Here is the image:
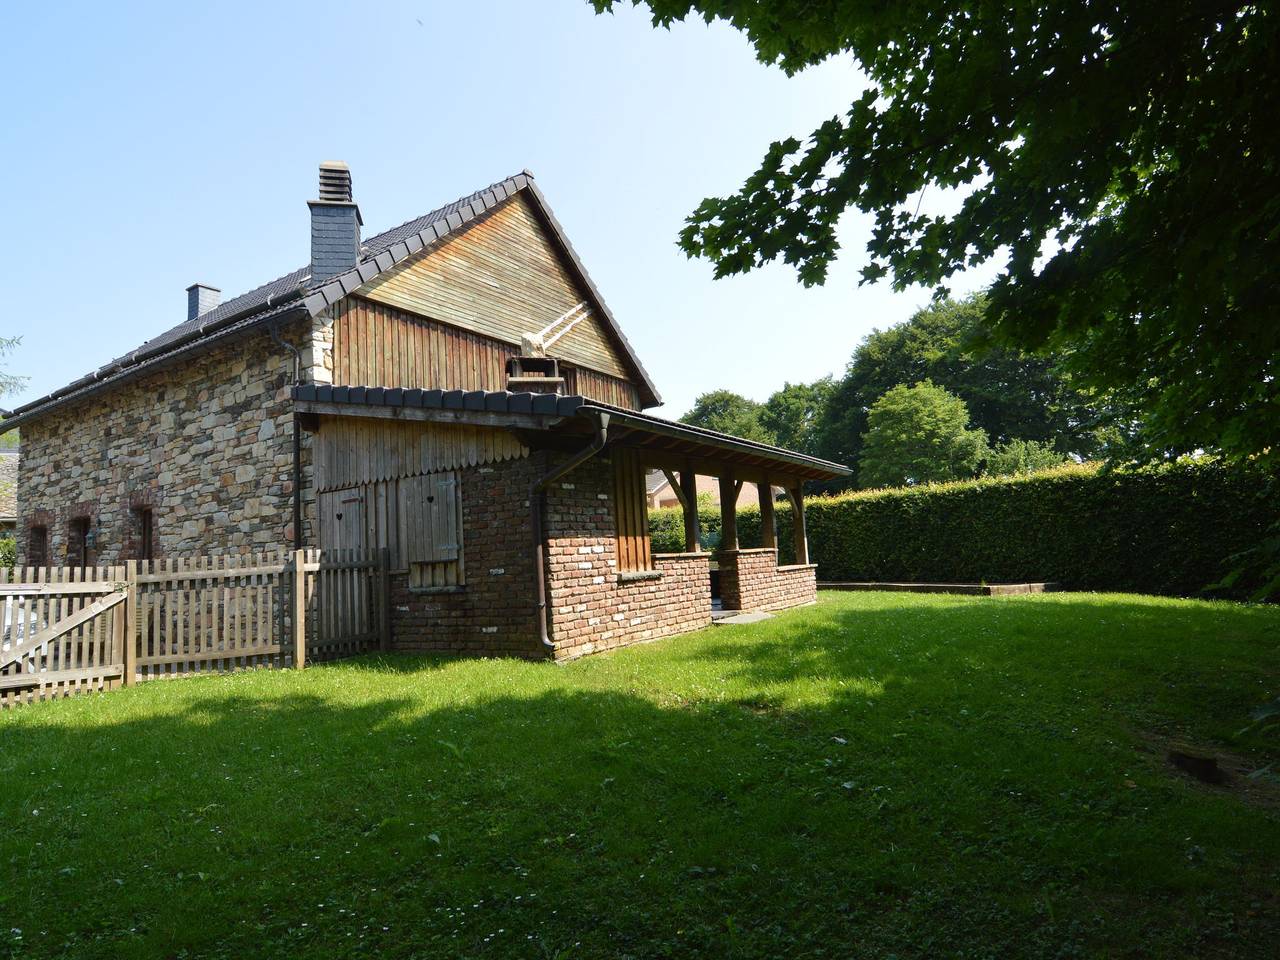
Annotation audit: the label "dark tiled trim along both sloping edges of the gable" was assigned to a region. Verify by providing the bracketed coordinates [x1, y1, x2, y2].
[303, 170, 662, 407]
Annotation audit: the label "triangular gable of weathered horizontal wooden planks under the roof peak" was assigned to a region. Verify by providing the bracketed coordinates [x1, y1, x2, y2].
[356, 193, 635, 389]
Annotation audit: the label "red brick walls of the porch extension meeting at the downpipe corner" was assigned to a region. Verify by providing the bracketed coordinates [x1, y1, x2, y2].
[392, 453, 712, 659]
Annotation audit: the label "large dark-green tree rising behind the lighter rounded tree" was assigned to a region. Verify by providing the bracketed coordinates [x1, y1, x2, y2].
[818, 294, 1134, 481]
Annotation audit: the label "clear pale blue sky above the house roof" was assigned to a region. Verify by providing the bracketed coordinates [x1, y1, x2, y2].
[0, 0, 992, 417]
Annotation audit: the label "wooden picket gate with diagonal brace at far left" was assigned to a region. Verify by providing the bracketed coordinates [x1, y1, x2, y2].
[0, 567, 128, 707]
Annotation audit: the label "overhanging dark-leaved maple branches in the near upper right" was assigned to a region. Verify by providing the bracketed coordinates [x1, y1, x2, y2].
[593, 0, 1280, 465]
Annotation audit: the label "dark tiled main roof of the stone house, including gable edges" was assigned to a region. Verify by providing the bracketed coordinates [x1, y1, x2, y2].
[0, 170, 662, 433]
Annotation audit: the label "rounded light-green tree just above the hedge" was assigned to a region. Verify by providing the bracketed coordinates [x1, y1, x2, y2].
[858, 380, 987, 486]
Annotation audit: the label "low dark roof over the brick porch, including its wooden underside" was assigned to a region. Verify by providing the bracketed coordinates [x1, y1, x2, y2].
[293, 384, 850, 483]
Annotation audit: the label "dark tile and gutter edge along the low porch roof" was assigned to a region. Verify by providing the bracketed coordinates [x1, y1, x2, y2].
[293, 384, 852, 479]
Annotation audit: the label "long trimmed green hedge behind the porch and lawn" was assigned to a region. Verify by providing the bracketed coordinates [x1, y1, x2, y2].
[650, 463, 1280, 596]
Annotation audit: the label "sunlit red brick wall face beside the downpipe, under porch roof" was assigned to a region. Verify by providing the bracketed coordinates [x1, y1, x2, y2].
[547, 457, 712, 659]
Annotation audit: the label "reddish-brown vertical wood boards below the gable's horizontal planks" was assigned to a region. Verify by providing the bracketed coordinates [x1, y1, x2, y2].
[333, 297, 640, 410]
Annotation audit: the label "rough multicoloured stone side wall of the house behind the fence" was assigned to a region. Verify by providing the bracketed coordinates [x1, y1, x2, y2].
[18, 321, 315, 564]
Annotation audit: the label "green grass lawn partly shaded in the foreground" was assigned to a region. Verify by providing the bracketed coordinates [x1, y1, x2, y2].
[0, 594, 1280, 957]
